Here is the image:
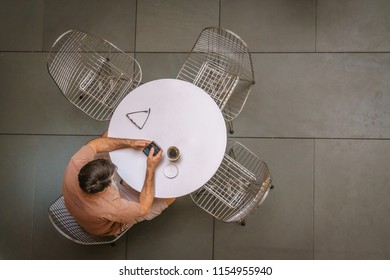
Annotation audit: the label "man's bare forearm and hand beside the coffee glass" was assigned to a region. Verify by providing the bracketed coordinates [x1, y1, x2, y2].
[139, 148, 162, 216]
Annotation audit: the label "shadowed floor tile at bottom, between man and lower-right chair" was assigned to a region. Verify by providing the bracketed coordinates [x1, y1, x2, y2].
[127, 196, 213, 260]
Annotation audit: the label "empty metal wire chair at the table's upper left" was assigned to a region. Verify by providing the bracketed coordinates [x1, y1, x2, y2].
[47, 29, 142, 121]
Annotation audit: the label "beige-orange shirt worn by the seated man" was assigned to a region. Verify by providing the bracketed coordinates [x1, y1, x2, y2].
[62, 144, 145, 235]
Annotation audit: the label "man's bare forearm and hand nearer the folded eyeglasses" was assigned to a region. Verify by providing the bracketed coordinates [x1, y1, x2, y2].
[88, 137, 150, 153]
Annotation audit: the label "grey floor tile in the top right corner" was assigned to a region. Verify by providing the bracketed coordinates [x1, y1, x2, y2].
[317, 0, 390, 52]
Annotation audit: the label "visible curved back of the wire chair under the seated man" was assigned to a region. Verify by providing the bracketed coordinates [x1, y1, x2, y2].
[49, 196, 126, 245]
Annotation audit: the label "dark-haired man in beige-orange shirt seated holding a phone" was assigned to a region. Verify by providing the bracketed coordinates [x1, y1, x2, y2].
[62, 134, 174, 236]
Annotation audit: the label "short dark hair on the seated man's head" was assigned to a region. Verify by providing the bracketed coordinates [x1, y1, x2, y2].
[79, 159, 116, 194]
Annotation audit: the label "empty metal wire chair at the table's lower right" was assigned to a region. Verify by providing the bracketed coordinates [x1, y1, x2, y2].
[191, 141, 273, 225]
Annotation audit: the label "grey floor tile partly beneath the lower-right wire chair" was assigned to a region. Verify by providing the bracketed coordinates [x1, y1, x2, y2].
[214, 138, 314, 259]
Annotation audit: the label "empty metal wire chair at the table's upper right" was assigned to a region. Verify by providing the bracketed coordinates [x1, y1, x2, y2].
[177, 27, 255, 133]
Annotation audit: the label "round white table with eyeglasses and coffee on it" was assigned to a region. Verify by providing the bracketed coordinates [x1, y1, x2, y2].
[108, 79, 227, 198]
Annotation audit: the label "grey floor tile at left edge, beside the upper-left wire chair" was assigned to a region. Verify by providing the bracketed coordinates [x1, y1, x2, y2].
[0, 53, 108, 135]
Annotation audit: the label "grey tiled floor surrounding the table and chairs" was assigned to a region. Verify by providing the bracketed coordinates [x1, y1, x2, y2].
[0, 0, 390, 259]
